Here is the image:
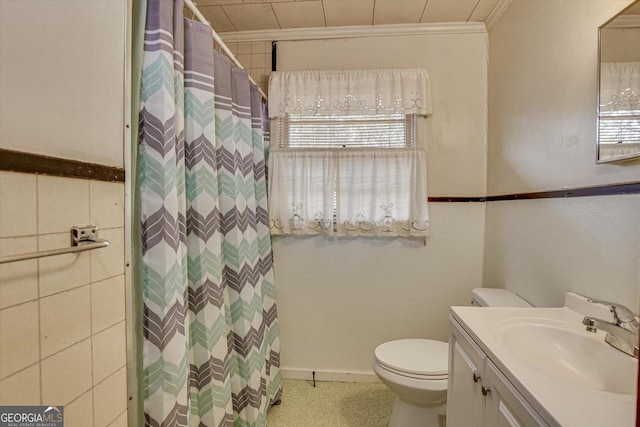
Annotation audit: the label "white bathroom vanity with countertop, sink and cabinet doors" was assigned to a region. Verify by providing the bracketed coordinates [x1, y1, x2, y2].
[447, 293, 638, 427]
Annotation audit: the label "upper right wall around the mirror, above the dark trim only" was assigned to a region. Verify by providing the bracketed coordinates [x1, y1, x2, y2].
[487, 0, 640, 195]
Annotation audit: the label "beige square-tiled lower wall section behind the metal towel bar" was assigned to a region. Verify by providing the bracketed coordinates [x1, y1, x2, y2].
[0, 172, 127, 427]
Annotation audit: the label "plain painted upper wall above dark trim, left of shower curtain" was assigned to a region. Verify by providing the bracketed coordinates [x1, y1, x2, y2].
[0, 0, 126, 167]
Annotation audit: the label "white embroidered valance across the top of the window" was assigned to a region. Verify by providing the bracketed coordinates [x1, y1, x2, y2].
[269, 69, 431, 118]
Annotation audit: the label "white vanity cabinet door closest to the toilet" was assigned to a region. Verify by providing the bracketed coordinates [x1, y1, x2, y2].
[447, 318, 485, 427]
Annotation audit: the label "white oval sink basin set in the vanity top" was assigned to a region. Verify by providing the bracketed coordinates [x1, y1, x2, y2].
[495, 318, 637, 395]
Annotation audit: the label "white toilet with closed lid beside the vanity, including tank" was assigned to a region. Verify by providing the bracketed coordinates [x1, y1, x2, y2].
[373, 288, 531, 427]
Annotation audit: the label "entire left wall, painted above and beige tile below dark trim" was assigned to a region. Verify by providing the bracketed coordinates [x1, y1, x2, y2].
[0, 1, 127, 427]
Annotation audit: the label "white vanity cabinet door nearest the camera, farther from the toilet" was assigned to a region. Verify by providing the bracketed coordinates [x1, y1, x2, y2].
[484, 360, 547, 427]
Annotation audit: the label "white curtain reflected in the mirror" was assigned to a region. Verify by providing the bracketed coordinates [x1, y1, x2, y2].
[600, 62, 640, 116]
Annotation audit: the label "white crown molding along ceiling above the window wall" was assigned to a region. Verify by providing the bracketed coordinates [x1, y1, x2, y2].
[219, 22, 487, 43]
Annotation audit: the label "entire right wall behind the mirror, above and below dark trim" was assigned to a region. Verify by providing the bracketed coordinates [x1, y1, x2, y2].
[483, 0, 640, 311]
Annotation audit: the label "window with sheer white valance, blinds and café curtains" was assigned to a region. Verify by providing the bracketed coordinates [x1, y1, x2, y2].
[269, 70, 430, 237]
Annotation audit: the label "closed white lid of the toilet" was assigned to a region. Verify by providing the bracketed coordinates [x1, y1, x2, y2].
[375, 339, 449, 377]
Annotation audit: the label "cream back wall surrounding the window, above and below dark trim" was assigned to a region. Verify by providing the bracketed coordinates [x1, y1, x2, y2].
[273, 32, 487, 378]
